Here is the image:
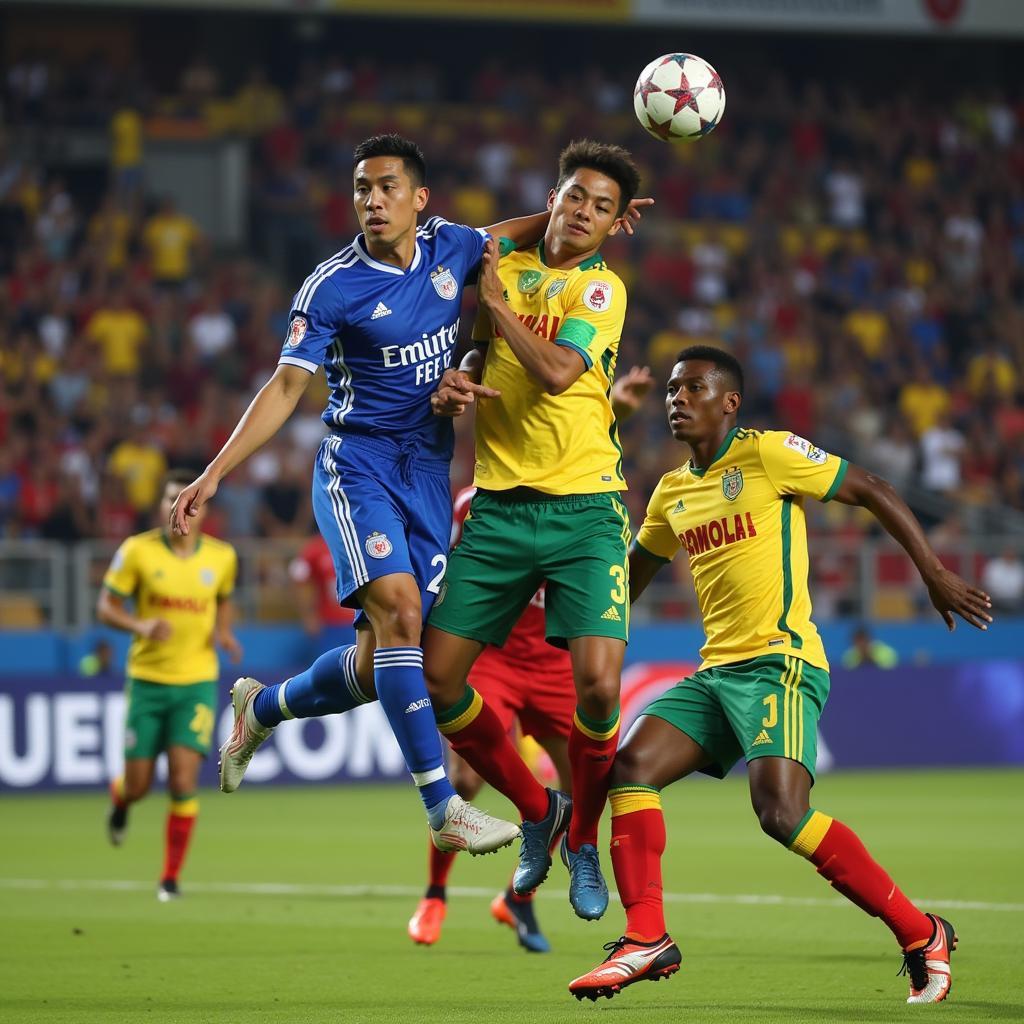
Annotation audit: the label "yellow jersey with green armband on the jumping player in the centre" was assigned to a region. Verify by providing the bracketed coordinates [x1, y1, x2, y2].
[473, 239, 626, 495]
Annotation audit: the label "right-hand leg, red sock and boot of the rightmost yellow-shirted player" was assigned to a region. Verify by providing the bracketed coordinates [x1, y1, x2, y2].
[750, 757, 956, 1002]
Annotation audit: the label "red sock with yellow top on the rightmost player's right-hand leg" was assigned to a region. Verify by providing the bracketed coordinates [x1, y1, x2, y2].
[787, 809, 932, 949]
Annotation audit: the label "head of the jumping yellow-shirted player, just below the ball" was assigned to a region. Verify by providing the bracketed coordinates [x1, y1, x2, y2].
[548, 138, 640, 252]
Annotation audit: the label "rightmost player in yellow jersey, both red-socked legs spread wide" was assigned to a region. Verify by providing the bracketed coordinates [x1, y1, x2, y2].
[569, 346, 992, 1002]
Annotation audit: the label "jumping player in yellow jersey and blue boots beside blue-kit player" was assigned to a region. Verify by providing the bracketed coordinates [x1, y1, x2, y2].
[424, 141, 639, 920]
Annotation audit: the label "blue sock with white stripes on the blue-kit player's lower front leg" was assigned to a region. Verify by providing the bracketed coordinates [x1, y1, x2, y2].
[374, 647, 456, 828]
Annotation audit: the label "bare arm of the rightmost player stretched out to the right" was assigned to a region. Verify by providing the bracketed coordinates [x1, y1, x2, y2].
[834, 464, 992, 631]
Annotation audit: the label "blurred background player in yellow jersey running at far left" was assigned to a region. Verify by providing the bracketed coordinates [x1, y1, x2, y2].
[96, 470, 242, 901]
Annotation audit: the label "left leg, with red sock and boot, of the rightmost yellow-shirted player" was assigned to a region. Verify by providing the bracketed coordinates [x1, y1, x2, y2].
[569, 716, 692, 999]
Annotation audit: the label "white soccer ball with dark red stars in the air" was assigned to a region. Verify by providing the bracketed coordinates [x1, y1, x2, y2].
[633, 53, 725, 142]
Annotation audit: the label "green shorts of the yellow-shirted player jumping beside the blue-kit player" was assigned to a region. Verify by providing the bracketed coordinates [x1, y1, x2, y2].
[429, 487, 630, 647]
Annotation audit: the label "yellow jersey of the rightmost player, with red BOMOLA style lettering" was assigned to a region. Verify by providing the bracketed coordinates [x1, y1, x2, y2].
[636, 427, 847, 671]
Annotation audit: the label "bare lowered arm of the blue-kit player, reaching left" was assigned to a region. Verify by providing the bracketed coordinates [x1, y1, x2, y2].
[170, 364, 312, 534]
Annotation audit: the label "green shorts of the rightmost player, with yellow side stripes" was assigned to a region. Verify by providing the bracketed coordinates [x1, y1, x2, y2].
[643, 654, 828, 781]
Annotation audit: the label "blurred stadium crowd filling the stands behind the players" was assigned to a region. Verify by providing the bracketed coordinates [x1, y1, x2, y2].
[0, 41, 1024, 606]
